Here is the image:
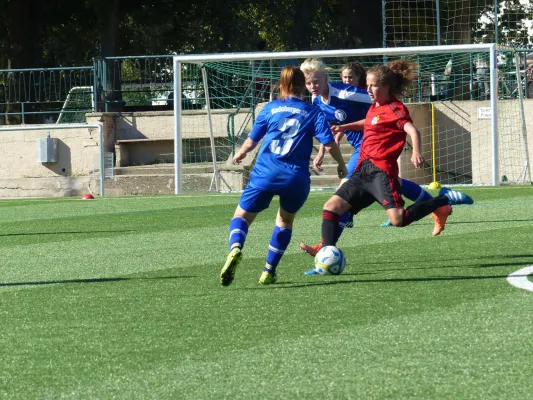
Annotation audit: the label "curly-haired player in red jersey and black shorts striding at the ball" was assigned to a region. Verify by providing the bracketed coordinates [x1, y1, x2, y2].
[322, 60, 473, 250]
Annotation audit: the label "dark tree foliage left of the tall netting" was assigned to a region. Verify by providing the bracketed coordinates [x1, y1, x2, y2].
[0, 0, 381, 68]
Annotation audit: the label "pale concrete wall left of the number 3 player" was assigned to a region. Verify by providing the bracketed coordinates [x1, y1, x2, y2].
[0, 109, 251, 197]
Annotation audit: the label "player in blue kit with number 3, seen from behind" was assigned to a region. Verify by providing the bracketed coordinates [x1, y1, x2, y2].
[220, 66, 347, 286]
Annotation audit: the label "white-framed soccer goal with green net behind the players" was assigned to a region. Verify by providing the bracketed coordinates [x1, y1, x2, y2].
[174, 44, 531, 193]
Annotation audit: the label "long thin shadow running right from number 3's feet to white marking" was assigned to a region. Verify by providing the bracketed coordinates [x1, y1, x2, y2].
[242, 274, 508, 290]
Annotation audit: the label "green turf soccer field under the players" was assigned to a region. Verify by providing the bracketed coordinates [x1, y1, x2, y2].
[0, 186, 533, 400]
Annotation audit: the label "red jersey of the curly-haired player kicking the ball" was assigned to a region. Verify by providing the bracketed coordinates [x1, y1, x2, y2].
[357, 97, 412, 177]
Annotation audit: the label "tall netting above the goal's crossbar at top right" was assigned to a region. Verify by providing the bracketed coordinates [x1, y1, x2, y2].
[382, 0, 533, 47]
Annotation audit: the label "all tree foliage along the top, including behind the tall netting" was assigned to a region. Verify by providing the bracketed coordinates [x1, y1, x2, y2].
[0, 0, 533, 68]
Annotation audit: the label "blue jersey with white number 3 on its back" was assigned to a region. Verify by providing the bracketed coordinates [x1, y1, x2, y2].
[249, 97, 334, 190]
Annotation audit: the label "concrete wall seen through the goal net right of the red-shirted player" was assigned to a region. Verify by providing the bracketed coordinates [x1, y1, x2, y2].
[399, 99, 533, 185]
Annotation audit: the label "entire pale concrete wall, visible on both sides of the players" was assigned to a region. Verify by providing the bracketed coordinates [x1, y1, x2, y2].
[0, 100, 533, 197]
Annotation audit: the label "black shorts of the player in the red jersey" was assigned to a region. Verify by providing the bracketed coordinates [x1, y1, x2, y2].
[335, 160, 404, 214]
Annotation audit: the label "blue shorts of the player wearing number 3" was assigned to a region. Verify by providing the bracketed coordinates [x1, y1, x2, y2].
[239, 182, 311, 214]
